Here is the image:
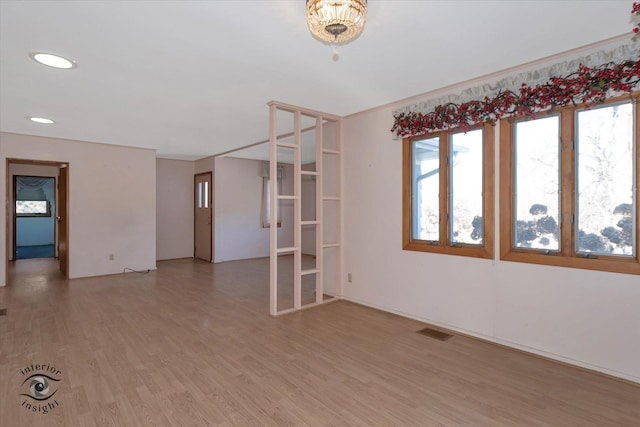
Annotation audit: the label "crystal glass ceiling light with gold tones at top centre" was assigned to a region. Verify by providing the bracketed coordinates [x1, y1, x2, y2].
[307, 0, 367, 45]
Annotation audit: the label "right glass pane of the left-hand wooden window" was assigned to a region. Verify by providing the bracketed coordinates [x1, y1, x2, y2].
[449, 129, 484, 245]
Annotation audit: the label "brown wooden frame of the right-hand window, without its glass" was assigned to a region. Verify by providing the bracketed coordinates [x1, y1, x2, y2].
[500, 92, 640, 274]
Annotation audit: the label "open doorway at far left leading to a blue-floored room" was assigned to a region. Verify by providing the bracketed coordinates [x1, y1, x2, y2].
[5, 159, 69, 283]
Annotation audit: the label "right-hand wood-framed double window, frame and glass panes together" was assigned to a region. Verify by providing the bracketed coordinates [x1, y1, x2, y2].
[500, 94, 640, 274]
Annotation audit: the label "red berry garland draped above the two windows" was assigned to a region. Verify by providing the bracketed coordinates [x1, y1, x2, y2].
[391, 59, 640, 137]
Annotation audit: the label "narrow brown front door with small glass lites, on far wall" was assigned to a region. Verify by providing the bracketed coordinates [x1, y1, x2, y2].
[193, 172, 213, 262]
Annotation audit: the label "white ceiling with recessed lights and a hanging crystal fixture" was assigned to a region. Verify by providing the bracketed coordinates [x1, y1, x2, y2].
[0, 0, 632, 159]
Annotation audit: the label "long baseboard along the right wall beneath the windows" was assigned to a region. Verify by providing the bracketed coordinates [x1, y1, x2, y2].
[342, 296, 640, 387]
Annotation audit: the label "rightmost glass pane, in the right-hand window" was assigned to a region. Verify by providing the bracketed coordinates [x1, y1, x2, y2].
[576, 103, 637, 255]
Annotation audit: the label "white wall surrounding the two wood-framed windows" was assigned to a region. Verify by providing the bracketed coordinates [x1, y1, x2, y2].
[344, 45, 640, 382]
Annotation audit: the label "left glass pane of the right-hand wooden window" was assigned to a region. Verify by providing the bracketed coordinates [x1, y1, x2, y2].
[513, 116, 560, 251]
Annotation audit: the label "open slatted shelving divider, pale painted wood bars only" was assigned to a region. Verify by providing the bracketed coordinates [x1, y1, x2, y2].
[268, 101, 343, 316]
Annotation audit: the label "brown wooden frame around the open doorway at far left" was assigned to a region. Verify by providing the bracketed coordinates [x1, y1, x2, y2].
[4, 157, 70, 285]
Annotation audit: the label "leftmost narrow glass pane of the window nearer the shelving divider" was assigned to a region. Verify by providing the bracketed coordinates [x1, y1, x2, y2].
[411, 138, 440, 241]
